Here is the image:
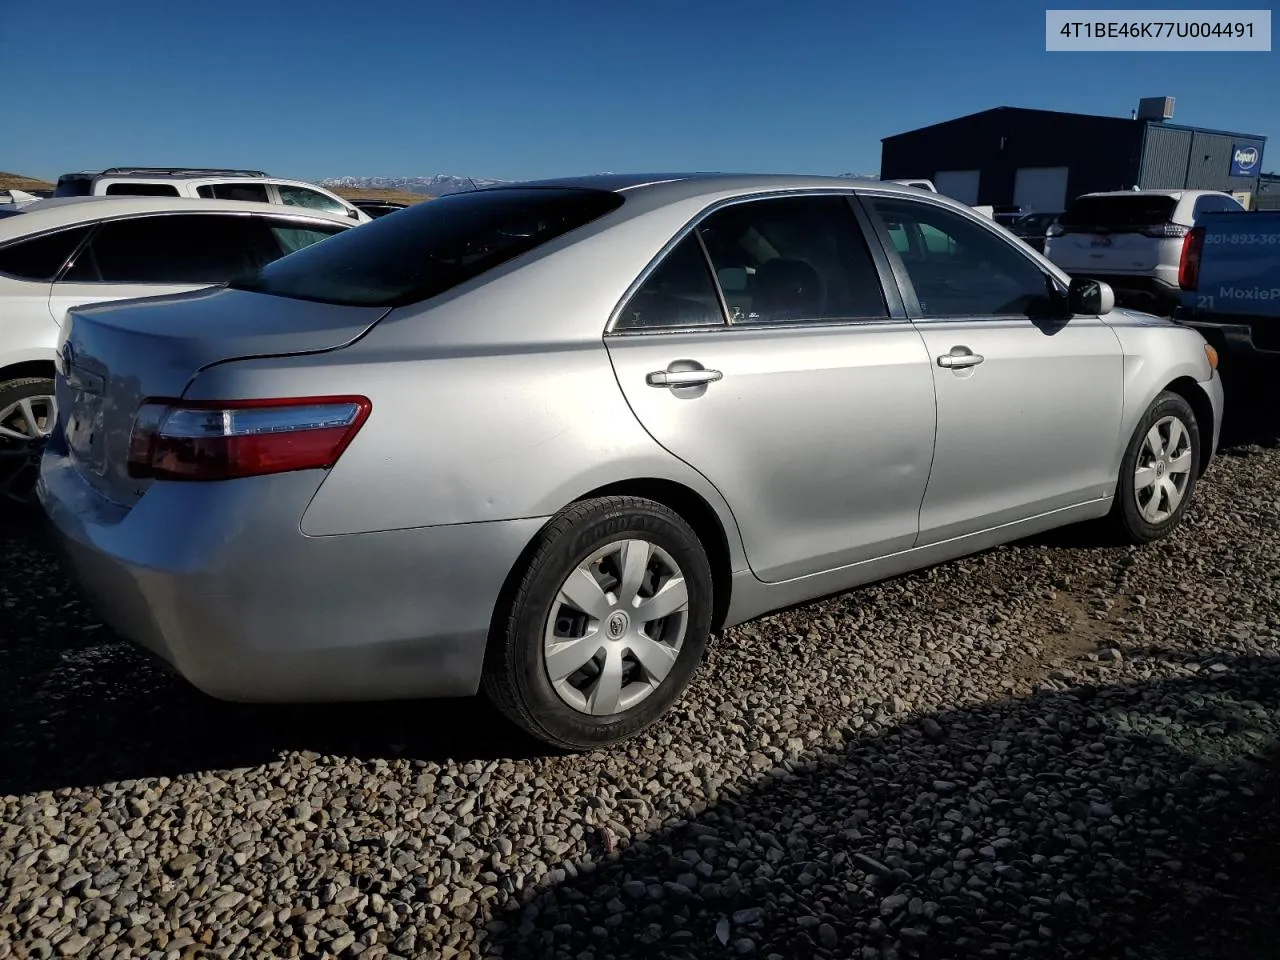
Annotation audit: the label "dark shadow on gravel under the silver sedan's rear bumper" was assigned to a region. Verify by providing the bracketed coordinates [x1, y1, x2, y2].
[0, 508, 538, 795]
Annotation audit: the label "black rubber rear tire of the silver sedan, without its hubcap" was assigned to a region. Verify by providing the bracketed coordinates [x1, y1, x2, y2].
[484, 497, 712, 750]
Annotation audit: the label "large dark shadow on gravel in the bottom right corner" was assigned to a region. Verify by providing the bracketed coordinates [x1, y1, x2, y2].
[477, 658, 1280, 960]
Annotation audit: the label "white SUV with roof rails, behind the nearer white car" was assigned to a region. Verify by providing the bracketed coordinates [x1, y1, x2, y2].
[54, 166, 372, 223]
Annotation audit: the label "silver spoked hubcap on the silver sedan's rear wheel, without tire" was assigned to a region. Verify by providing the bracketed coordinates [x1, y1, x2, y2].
[543, 540, 689, 717]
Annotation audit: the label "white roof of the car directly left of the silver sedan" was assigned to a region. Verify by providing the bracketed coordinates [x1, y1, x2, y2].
[0, 197, 356, 239]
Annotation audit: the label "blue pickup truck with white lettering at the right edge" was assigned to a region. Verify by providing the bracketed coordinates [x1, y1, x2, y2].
[1174, 211, 1280, 357]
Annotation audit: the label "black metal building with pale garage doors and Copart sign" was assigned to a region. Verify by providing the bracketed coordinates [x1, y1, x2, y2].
[881, 97, 1266, 212]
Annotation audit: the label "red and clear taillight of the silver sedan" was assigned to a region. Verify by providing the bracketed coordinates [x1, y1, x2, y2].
[129, 397, 372, 480]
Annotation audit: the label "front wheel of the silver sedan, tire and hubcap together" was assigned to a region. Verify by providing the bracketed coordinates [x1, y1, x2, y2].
[1111, 392, 1201, 544]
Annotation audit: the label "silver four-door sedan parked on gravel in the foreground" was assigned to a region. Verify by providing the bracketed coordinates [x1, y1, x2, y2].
[40, 175, 1222, 749]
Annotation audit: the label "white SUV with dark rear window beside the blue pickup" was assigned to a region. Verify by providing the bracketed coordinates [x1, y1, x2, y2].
[1044, 189, 1244, 315]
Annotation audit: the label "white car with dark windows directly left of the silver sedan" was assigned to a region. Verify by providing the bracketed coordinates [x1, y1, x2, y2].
[0, 197, 356, 502]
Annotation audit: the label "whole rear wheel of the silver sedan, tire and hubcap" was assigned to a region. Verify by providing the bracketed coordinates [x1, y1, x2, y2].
[484, 497, 712, 750]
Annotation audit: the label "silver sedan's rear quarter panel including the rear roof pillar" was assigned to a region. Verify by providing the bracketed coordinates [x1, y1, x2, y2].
[186, 202, 746, 570]
